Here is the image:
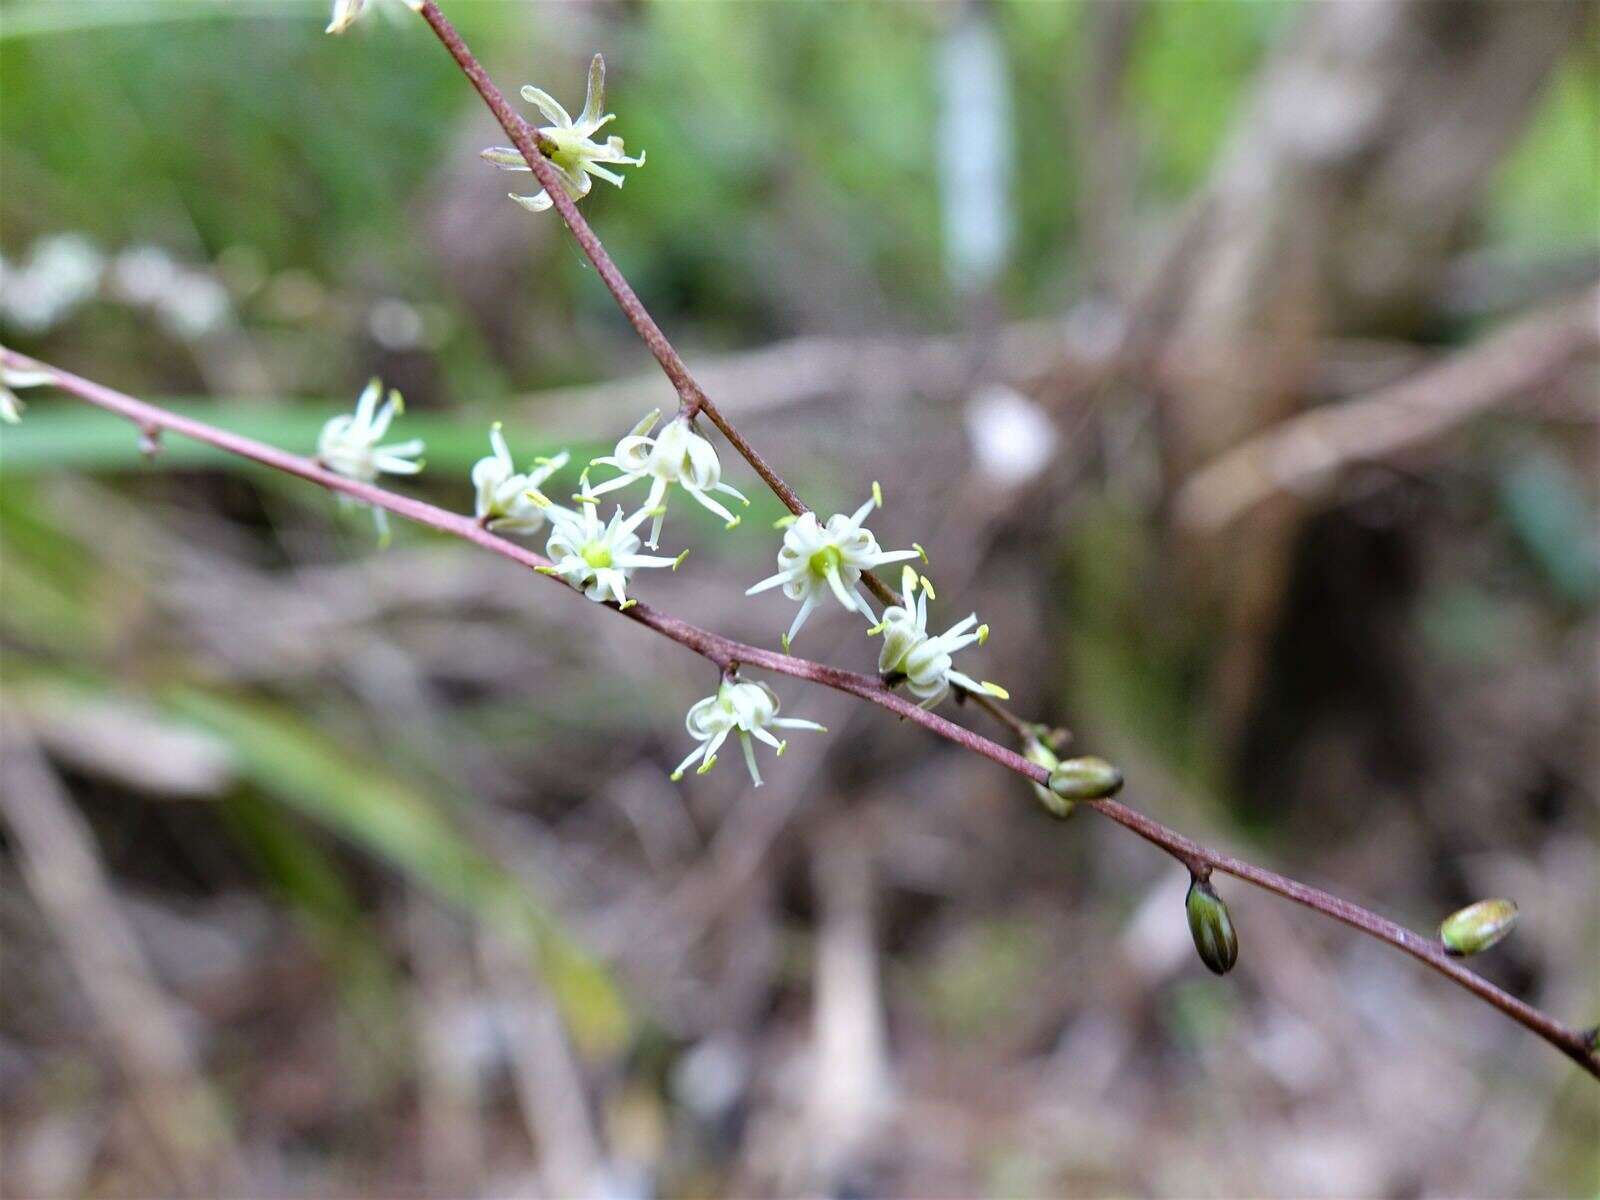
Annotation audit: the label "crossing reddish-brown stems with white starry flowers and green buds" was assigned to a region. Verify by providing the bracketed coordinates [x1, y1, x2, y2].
[0, 0, 1600, 1078]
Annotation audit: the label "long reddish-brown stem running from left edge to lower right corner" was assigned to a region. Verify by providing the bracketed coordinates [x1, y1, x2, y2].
[15, 347, 1600, 1080]
